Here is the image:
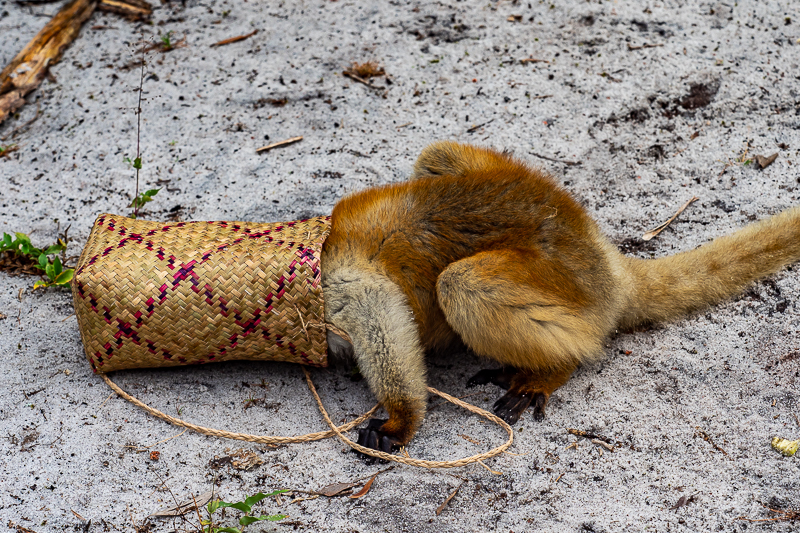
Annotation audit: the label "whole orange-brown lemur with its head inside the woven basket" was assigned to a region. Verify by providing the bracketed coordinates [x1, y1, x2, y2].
[321, 142, 800, 451]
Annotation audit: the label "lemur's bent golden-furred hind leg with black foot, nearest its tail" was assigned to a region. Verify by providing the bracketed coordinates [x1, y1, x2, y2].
[436, 250, 604, 424]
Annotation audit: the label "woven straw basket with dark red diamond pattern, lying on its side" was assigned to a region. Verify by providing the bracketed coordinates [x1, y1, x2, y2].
[72, 214, 330, 373]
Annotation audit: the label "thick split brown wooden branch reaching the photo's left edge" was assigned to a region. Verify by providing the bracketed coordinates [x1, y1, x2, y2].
[0, 0, 98, 123]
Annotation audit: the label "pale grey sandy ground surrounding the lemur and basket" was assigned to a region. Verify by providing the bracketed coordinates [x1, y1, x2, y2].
[0, 0, 800, 533]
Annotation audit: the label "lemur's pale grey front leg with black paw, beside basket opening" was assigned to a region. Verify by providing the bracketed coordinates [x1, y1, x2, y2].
[322, 265, 428, 450]
